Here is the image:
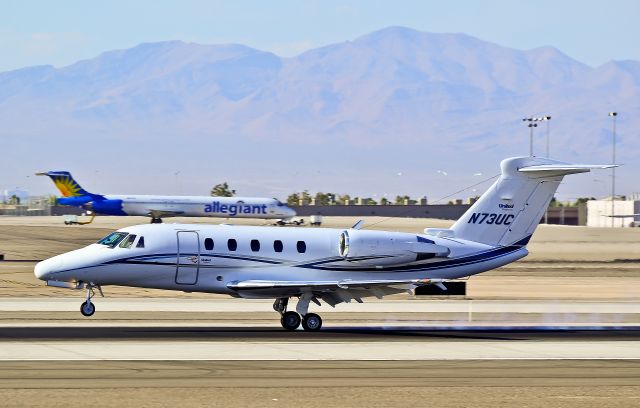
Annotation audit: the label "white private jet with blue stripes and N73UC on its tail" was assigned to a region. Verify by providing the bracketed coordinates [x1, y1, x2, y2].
[35, 157, 611, 331]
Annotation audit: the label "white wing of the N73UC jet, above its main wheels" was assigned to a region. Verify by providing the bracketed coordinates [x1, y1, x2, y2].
[227, 279, 446, 306]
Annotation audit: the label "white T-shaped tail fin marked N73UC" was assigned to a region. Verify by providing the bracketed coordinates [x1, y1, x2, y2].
[451, 157, 614, 245]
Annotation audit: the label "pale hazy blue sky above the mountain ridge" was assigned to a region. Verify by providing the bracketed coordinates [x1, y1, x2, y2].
[0, 0, 640, 71]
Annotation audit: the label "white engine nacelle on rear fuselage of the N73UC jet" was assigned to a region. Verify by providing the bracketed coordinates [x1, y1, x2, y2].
[338, 229, 451, 266]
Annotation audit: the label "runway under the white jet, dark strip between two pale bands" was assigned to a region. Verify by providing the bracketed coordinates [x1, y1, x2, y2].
[0, 298, 640, 361]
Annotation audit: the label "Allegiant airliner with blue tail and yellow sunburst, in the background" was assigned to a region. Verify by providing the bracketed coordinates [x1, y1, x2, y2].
[36, 171, 296, 224]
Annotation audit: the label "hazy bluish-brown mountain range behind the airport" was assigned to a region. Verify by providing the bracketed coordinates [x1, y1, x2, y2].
[0, 27, 640, 198]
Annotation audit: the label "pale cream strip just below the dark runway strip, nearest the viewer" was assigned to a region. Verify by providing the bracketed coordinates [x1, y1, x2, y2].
[0, 341, 640, 361]
